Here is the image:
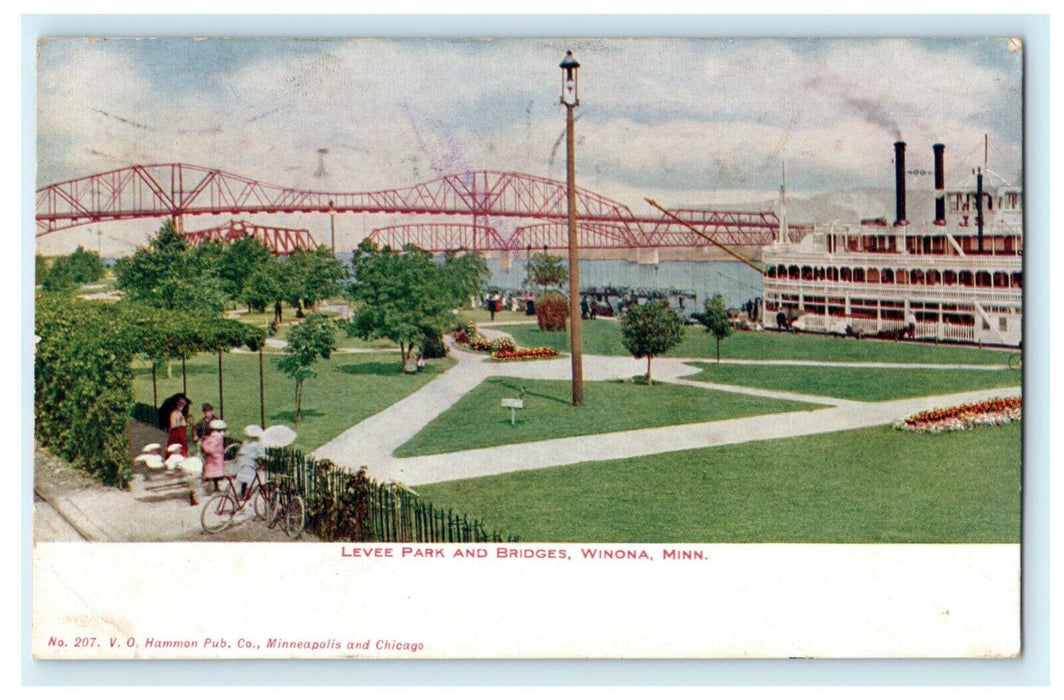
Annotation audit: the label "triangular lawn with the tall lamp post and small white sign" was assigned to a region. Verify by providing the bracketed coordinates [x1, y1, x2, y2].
[395, 377, 821, 456]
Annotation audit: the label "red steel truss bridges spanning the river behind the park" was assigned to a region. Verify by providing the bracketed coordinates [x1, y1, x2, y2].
[36, 163, 795, 252]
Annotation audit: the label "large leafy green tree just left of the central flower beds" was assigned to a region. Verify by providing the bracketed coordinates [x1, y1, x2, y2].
[348, 245, 480, 371]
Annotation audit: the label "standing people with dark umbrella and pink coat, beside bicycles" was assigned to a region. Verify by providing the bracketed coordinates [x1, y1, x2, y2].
[159, 394, 266, 505]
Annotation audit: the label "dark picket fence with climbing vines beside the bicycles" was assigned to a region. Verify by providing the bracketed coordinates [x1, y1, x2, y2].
[266, 449, 517, 543]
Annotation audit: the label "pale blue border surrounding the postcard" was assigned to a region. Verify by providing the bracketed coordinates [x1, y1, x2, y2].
[18, 9, 1050, 685]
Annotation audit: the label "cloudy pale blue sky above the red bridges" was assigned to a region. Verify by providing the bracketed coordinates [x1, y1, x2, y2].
[37, 38, 1023, 253]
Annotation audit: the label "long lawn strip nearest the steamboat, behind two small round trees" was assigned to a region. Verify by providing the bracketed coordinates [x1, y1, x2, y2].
[503, 320, 1009, 365]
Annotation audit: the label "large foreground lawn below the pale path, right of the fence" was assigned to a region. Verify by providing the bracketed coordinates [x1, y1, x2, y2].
[418, 423, 1021, 544]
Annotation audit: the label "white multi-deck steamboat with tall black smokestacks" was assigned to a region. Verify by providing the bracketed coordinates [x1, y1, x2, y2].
[763, 141, 1024, 346]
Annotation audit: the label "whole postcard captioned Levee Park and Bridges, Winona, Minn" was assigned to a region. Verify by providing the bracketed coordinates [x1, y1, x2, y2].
[32, 30, 1025, 660]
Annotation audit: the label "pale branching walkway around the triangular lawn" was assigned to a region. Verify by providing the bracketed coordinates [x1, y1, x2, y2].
[313, 327, 1020, 486]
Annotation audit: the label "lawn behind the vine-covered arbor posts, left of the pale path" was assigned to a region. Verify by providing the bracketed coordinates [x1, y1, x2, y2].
[133, 353, 454, 451]
